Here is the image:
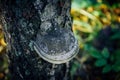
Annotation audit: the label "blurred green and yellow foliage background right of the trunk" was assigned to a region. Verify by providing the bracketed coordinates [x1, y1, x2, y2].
[71, 0, 120, 80]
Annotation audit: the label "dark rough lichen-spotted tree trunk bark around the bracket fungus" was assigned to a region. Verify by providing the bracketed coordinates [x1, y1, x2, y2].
[0, 0, 72, 80]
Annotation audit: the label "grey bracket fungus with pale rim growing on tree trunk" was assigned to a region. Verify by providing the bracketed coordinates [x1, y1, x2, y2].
[34, 27, 79, 64]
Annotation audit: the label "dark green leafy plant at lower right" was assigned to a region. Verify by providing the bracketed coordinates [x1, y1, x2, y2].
[89, 46, 120, 73]
